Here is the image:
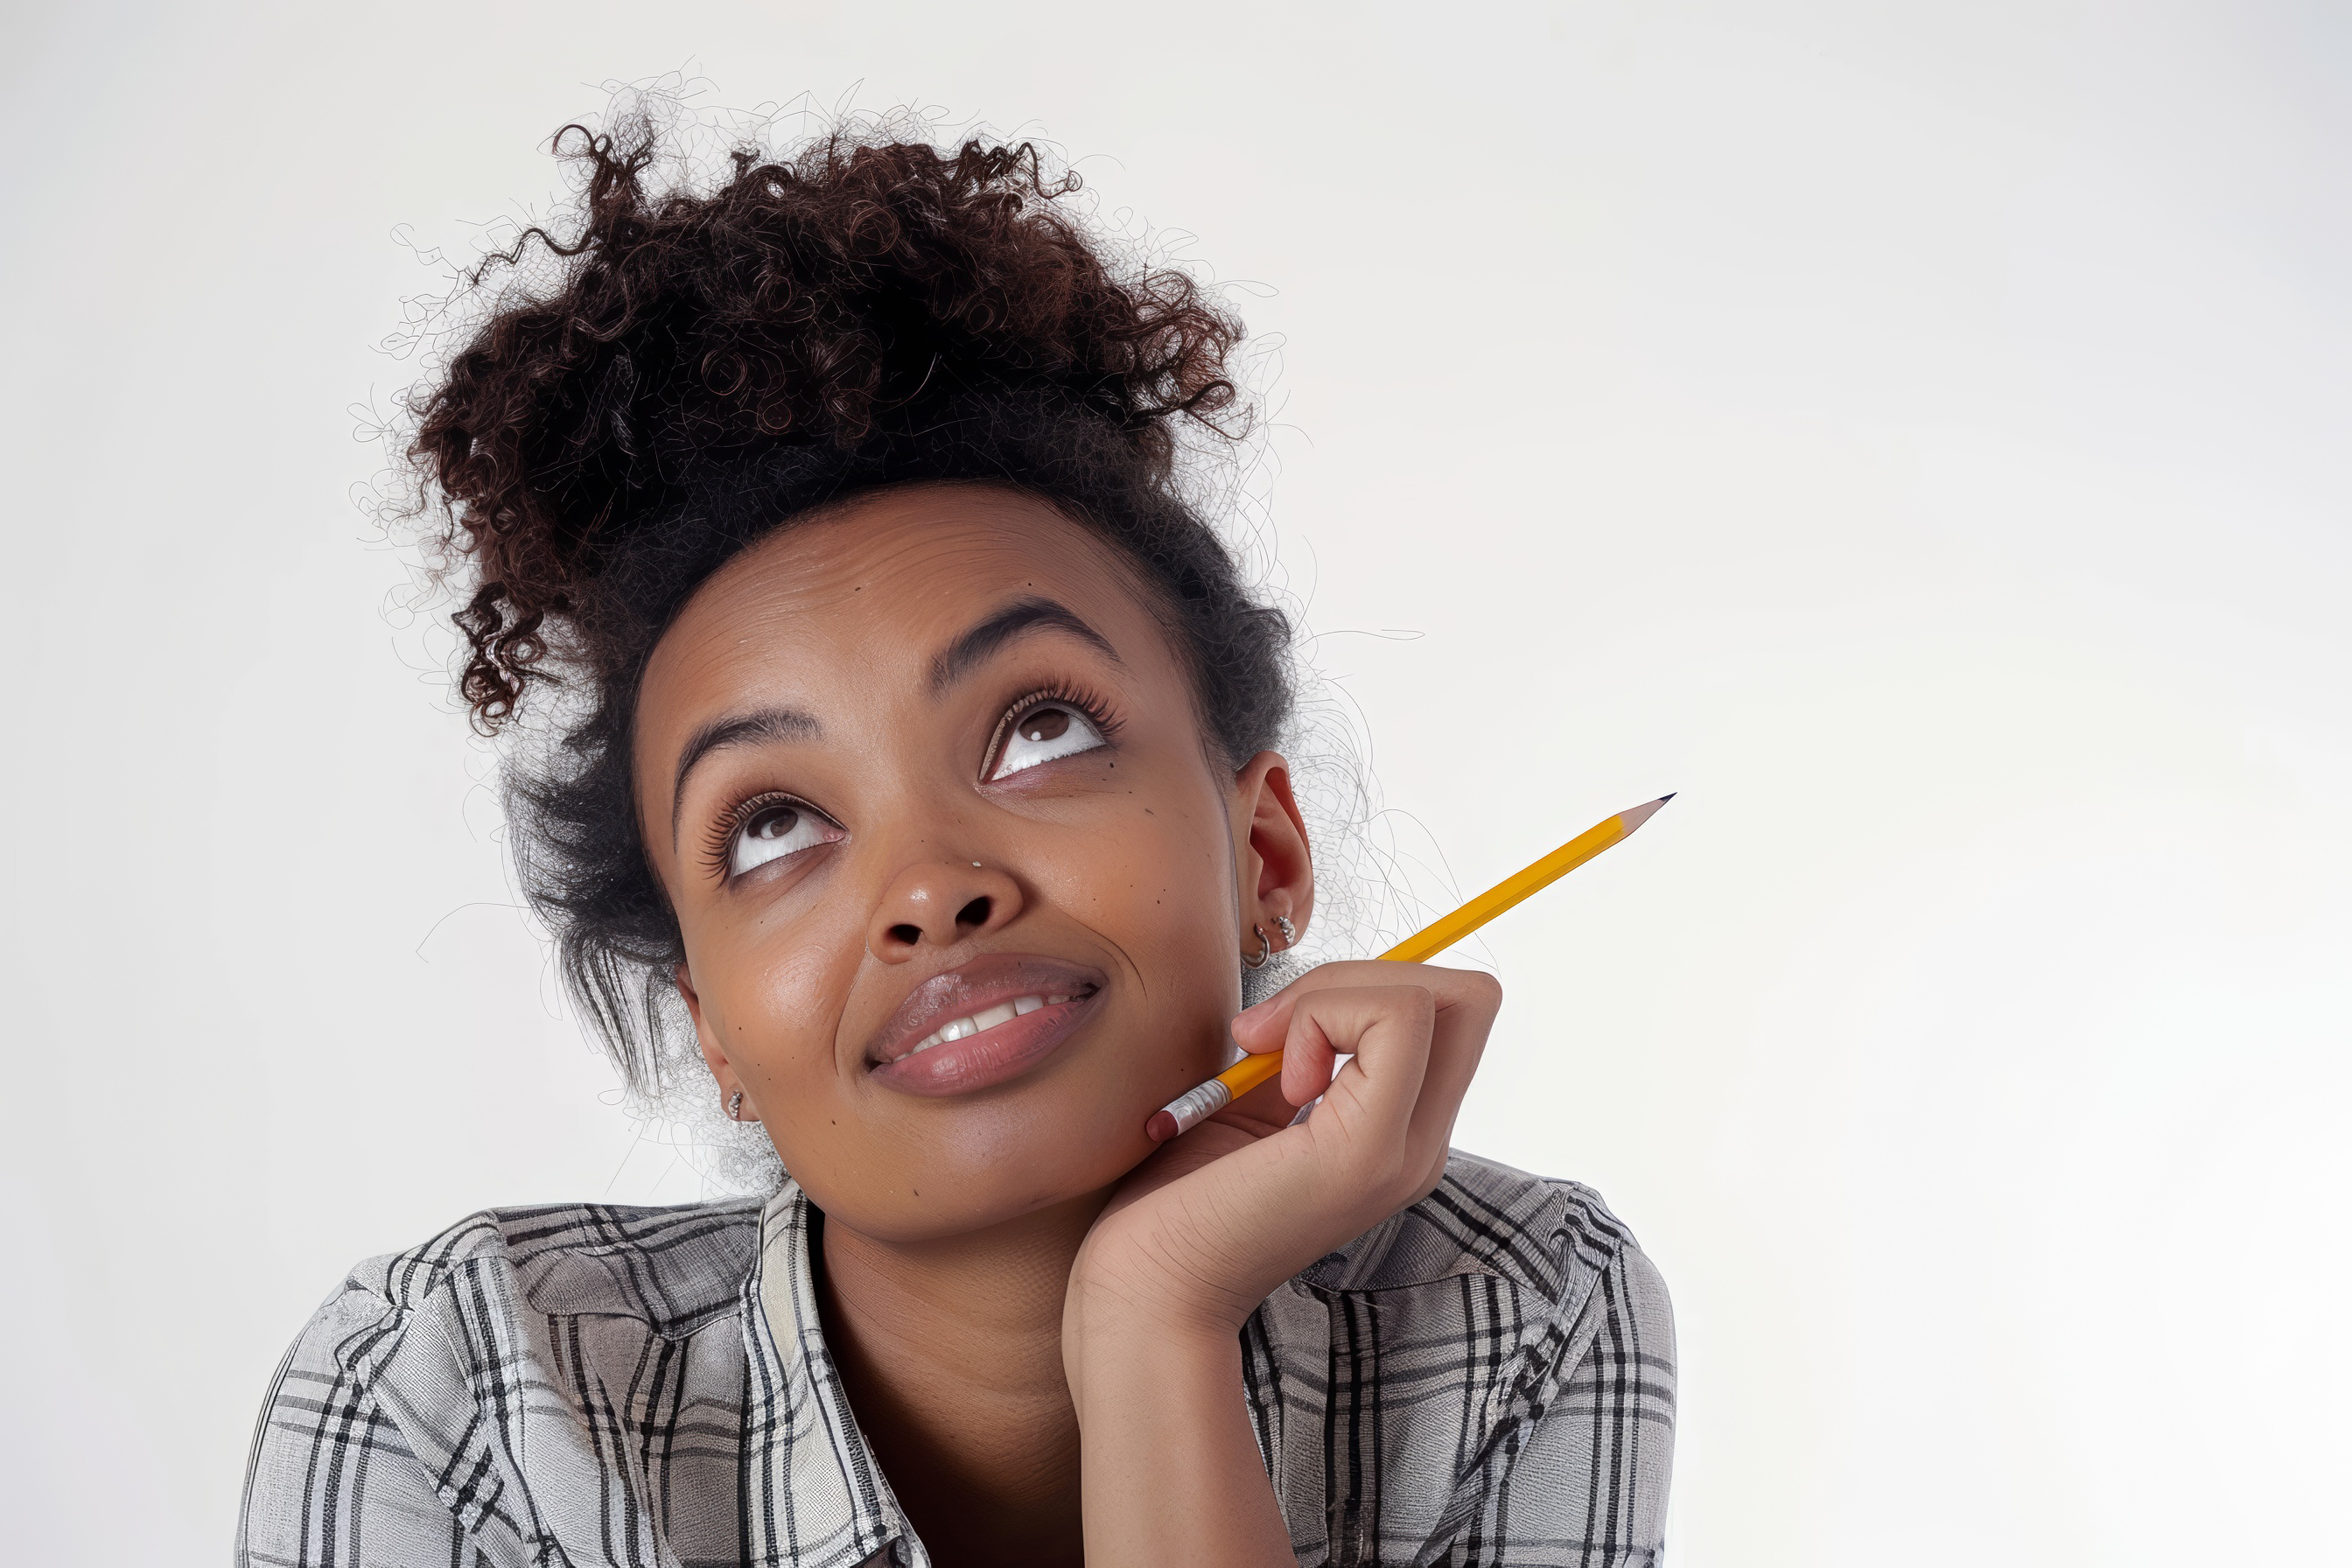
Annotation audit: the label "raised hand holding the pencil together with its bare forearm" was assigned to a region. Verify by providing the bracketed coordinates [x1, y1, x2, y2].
[1060, 962, 1503, 1568]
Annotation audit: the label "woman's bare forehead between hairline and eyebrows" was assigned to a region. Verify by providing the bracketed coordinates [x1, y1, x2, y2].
[637, 484, 1169, 738]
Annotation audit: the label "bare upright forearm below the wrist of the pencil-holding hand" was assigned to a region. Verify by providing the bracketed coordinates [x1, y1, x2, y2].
[1073, 1331, 1298, 1568]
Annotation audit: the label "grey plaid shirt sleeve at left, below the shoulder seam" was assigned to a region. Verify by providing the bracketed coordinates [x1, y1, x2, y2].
[235, 1286, 485, 1568]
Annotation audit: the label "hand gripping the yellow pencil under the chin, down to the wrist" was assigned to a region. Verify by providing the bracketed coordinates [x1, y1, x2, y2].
[1063, 962, 1503, 1354]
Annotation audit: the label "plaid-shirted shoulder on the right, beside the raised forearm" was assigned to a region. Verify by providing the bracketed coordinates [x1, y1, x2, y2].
[1242, 1152, 1675, 1564]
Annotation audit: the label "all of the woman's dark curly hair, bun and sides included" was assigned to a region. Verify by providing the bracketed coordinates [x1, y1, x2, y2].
[410, 120, 1293, 1096]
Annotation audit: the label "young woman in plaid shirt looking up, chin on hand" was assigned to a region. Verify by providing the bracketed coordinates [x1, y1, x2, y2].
[240, 120, 1672, 1568]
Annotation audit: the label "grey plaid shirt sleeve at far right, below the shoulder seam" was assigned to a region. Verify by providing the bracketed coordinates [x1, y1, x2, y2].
[1439, 1243, 1675, 1568]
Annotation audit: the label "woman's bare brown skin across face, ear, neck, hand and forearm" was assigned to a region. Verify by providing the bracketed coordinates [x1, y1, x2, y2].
[633, 484, 1501, 1568]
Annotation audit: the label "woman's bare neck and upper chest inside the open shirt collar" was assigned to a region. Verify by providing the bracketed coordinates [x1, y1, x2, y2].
[816, 1192, 1108, 1568]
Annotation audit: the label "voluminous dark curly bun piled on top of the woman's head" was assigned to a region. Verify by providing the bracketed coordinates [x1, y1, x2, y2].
[410, 116, 1242, 724]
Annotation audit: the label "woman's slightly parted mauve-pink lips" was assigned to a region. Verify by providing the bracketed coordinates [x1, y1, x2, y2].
[865, 955, 1105, 1098]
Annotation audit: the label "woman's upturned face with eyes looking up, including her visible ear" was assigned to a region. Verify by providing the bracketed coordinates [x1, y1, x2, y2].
[633, 484, 1310, 1242]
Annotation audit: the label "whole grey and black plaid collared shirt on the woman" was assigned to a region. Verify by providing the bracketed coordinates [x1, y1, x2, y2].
[237, 1154, 1675, 1568]
